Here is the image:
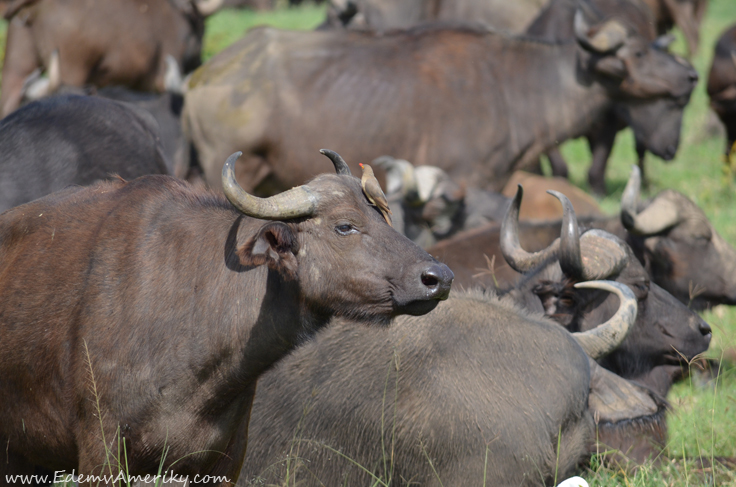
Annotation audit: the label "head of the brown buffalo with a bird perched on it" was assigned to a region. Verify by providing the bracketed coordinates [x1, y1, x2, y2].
[223, 150, 454, 323]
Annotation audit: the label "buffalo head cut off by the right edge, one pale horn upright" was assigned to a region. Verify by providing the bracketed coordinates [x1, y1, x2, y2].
[621, 167, 736, 309]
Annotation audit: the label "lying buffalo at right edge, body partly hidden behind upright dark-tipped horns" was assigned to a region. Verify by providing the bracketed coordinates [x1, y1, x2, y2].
[427, 168, 736, 309]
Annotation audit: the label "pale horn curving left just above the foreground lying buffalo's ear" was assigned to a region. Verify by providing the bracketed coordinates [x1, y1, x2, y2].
[572, 281, 638, 360]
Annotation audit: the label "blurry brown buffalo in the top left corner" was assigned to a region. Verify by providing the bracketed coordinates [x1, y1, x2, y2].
[0, 0, 222, 116]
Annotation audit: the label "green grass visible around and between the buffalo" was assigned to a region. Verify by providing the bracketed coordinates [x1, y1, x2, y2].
[0, 0, 736, 487]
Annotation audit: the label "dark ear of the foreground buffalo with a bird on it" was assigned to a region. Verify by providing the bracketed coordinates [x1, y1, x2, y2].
[235, 222, 299, 279]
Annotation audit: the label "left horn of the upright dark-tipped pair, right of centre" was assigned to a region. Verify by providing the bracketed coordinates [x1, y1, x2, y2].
[500, 184, 565, 273]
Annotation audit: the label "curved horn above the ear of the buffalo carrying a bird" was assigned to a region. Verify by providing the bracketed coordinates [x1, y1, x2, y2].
[222, 152, 318, 220]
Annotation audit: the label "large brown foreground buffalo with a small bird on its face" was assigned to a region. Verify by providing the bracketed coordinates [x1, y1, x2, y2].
[0, 152, 452, 485]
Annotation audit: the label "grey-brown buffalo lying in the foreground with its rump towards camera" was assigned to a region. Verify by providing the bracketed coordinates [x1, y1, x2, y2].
[239, 280, 662, 486]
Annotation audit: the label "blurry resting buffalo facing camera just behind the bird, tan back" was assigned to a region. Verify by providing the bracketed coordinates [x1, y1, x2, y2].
[373, 156, 603, 247]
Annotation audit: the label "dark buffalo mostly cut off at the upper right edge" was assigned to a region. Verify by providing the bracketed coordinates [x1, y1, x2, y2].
[708, 25, 736, 163]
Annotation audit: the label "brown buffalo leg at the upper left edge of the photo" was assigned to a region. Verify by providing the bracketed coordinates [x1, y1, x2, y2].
[0, 17, 40, 117]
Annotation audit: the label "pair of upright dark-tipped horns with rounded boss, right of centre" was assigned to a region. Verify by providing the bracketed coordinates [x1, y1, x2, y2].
[500, 185, 628, 281]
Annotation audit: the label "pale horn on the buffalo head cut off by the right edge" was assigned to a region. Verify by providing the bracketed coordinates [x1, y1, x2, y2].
[621, 166, 680, 236]
